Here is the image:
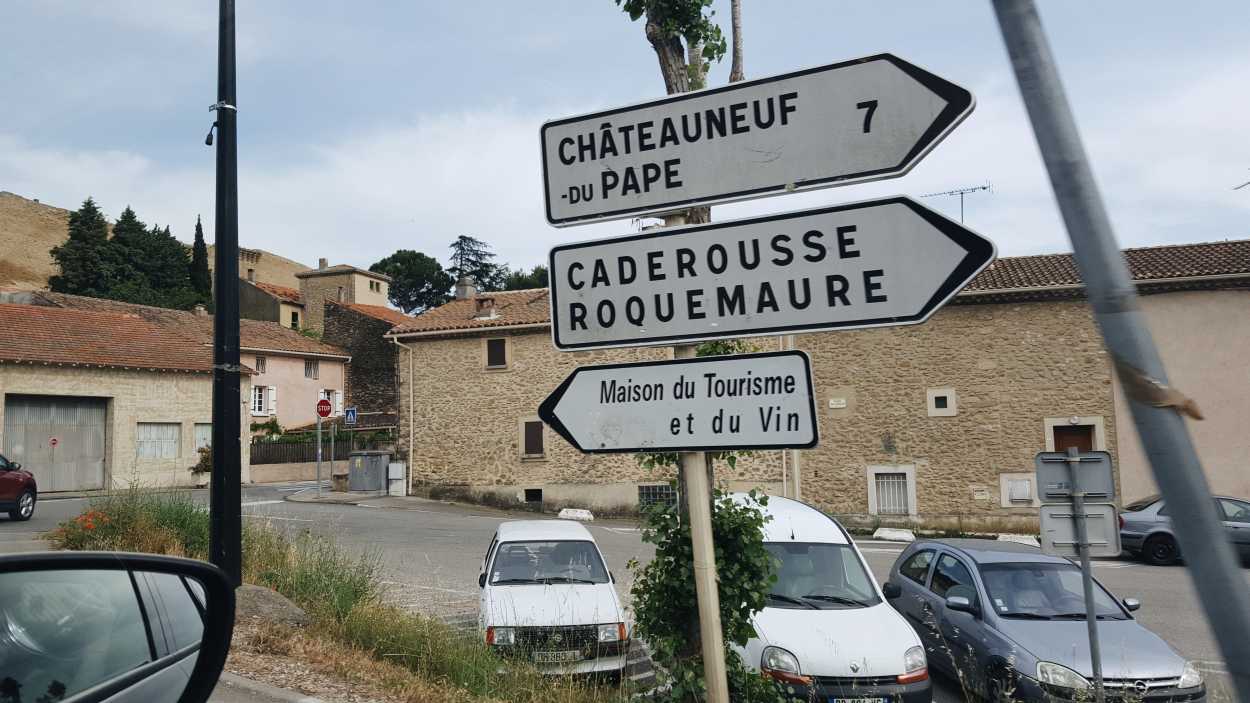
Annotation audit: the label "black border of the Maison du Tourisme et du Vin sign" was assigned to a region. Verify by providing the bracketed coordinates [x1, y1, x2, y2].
[539, 349, 820, 454]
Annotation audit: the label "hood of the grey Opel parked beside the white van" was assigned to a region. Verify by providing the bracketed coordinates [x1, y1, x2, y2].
[999, 618, 1185, 679]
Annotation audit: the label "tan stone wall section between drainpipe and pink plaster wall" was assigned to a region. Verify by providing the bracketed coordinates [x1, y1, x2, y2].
[798, 295, 1116, 528]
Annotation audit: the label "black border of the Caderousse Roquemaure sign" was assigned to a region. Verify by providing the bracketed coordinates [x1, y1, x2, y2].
[548, 195, 995, 352]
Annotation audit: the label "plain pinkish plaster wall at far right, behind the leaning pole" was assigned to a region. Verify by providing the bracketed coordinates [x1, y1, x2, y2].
[1115, 290, 1250, 502]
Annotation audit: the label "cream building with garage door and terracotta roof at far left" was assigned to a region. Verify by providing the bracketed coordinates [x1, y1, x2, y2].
[0, 304, 251, 493]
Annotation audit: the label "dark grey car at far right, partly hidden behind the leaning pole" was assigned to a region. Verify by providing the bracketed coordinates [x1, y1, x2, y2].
[1120, 495, 1250, 565]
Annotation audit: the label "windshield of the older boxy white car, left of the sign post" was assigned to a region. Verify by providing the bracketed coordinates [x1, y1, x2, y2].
[490, 542, 608, 585]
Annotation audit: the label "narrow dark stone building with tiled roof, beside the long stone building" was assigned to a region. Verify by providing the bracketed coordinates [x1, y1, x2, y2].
[321, 295, 413, 429]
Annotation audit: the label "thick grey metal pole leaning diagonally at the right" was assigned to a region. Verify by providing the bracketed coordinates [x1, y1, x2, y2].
[994, 0, 1250, 700]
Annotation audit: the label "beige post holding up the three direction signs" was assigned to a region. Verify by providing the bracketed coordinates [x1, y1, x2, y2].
[664, 214, 729, 703]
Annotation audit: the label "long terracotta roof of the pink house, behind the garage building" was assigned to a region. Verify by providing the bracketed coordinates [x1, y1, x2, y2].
[39, 291, 349, 358]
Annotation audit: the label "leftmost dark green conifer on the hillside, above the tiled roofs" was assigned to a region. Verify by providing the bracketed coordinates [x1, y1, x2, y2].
[48, 198, 131, 298]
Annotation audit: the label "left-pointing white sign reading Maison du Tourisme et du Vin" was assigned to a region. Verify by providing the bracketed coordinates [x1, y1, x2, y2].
[539, 352, 818, 454]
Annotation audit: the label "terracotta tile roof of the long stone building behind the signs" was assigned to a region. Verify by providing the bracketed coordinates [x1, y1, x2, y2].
[391, 239, 1250, 334]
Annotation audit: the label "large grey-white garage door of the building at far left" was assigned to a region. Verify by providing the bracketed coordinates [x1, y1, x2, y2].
[3, 395, 108, 493]
